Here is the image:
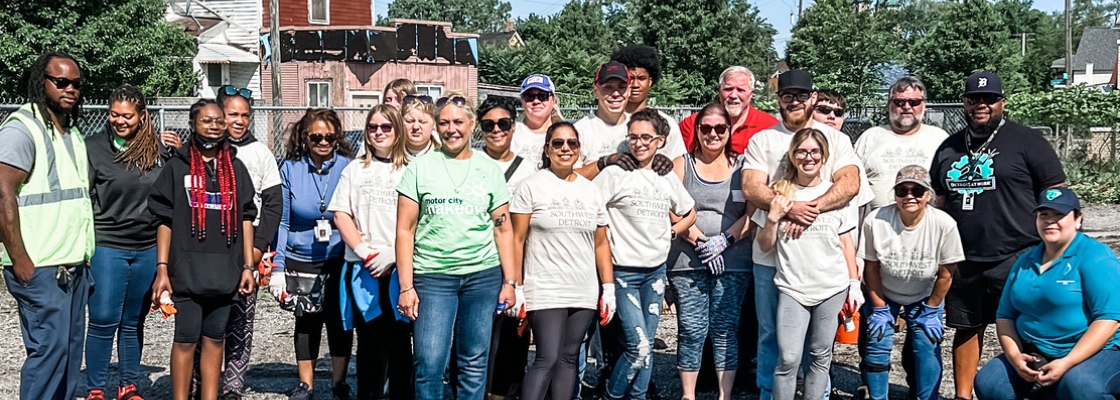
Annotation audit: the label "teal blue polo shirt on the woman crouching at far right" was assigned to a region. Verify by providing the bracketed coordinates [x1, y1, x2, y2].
[996, 232, 1120, 357]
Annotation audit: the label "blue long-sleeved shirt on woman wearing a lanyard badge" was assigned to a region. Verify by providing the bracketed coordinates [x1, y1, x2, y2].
[273, 155, 351, 271]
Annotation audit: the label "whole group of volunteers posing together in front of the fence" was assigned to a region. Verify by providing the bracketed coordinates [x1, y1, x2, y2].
[0, 45, 1120, 400]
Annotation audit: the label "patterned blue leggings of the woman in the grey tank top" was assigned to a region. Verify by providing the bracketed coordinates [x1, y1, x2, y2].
[669, 270, 750, 372]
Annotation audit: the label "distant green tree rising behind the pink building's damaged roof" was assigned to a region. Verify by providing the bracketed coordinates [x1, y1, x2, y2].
[385, 0, 513, 34]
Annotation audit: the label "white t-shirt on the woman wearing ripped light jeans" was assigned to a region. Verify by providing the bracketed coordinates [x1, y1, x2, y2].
[595, 166, 696, 268]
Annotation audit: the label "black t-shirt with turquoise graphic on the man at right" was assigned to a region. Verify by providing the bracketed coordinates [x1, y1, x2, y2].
[930, 121, 1065, 261]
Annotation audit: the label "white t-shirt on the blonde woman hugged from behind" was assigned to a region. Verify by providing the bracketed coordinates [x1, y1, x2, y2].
[750, 182, 859, 306]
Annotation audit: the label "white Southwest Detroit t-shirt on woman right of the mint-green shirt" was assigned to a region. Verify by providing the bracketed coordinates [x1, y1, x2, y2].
[510, 170, 609, 311]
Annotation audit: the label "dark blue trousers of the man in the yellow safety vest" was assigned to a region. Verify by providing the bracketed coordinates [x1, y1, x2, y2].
[3, 264, 91, 400]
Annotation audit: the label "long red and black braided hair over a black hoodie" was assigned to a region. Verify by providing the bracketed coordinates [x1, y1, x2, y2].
[188, 99, 237, 245]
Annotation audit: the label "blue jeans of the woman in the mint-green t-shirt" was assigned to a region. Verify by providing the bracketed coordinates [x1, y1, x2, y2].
[412, 264, 502, 400]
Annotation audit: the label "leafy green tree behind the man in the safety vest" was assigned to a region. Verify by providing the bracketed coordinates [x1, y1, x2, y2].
[0, 0, 198, 99]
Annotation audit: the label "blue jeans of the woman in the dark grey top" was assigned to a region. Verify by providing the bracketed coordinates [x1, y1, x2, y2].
[85, 245, 156, 389]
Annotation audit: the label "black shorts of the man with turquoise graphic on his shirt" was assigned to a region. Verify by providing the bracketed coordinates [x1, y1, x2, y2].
[945, 248, 1030, 329]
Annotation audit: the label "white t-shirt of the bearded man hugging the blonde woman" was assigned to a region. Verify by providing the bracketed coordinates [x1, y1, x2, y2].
[743, 121, 875, 267]
